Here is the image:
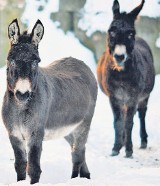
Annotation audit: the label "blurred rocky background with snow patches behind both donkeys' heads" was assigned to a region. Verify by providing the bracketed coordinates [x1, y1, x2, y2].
[0, 0, 160, 73]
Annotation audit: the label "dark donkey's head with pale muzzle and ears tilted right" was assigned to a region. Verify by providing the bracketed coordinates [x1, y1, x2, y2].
[108, 0, 144, 69]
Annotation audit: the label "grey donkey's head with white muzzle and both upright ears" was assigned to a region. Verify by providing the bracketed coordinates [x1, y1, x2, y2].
[7, 19, 44, 103]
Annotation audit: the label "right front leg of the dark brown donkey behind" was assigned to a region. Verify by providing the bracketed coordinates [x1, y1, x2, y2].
[125, 107, 136, 158]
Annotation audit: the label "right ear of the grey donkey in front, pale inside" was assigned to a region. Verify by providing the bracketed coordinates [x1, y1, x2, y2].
[31, 19, 44, 46]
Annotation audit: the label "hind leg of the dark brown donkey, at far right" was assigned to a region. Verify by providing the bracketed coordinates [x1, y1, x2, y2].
[138, 98, 148, 149]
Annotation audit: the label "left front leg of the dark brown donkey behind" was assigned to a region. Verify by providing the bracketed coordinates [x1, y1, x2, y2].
[110, 99, 124, 156]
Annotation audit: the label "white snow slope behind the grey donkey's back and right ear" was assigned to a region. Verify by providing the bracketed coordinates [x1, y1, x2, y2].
[22, 0, 94, 72]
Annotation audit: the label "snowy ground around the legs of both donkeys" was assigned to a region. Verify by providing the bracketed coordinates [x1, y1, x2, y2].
[0, 72, 160, 186]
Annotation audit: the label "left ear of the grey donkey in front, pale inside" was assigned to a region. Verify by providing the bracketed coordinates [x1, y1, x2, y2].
[8, 19, 20, 45]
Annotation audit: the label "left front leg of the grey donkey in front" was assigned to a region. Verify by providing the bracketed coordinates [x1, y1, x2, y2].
[9, 135, 27, 181]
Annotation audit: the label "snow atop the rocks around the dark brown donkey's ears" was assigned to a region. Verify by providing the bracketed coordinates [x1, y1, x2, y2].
[78, 0, 160, 36]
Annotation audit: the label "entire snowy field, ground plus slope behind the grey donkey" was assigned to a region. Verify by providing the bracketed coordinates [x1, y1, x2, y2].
[0, 0, 160, 186]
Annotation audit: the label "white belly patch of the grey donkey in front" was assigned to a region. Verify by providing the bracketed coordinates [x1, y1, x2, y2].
[43, 121, 82, 141]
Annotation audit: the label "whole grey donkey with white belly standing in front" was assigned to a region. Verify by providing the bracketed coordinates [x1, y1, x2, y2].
[2, 19, 97, 184]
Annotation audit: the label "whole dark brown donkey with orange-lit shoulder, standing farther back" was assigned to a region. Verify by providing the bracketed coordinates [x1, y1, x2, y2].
[97, 0, 155, 157]
